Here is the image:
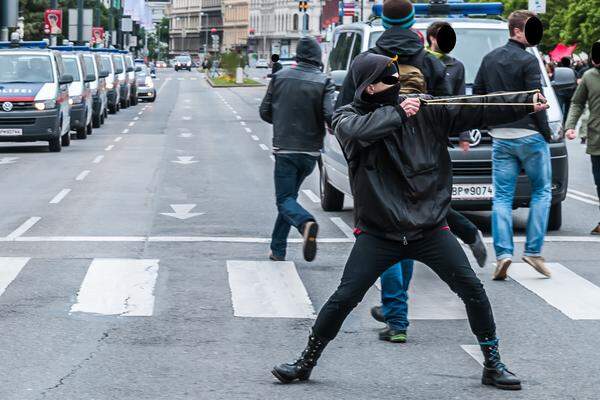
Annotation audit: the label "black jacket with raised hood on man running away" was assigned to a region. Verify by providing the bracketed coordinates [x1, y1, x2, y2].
[260, 37, 335, 152]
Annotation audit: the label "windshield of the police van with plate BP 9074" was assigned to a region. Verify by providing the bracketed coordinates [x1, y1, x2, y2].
[369, 28, 508, 85]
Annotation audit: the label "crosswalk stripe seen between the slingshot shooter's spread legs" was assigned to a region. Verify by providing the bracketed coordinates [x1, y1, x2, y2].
[375, 265, 467, 320]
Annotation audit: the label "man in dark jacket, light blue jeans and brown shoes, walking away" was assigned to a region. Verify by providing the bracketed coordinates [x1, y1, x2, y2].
[473, 10, 552, 280]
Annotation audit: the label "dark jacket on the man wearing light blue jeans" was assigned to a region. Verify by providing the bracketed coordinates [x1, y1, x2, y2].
[473, 39, 552, 141]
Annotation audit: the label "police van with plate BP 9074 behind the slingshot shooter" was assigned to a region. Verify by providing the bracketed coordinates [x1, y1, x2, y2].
[320, 1, 568, 230]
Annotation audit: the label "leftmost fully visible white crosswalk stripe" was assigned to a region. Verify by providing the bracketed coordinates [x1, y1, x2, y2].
[71, 258, 159, 317]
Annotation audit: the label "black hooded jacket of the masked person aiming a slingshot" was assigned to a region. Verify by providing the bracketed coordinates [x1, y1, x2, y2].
[333, 54, 533, 243]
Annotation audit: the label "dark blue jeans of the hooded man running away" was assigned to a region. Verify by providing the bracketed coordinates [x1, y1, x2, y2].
[271, 154, 317, 258]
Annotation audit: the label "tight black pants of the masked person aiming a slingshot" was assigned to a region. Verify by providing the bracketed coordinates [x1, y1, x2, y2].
[313, 230, 496, 341]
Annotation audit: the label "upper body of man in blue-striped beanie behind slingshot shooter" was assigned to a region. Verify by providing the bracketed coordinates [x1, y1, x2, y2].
[335, 0, 451, 108]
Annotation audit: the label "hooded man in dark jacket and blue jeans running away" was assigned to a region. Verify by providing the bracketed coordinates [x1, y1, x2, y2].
[260, 37, 335, 261]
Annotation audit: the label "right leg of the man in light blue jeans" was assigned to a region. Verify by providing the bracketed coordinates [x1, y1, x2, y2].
[518, 135, 552, 257]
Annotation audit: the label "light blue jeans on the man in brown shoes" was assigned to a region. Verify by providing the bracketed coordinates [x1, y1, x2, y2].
[492, 134, 552, 260]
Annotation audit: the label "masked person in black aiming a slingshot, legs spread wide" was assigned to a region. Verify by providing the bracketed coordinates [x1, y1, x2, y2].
[272, 53, 547, 389]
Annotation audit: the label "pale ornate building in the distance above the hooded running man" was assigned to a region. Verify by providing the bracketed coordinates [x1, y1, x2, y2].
[248, 0, 324, 58]
